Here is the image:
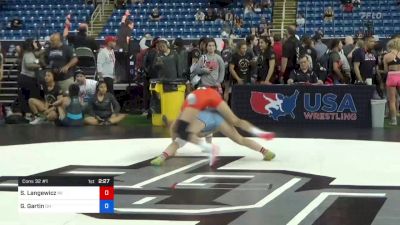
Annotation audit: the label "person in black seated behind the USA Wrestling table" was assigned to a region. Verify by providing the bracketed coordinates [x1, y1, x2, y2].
[288, 55, 323, 85]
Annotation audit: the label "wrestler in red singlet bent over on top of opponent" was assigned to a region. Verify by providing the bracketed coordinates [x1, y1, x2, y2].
[171, 87, 275, 165]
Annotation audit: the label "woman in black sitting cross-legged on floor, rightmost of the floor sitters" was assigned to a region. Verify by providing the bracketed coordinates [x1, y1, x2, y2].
[85, 81, 126, 125]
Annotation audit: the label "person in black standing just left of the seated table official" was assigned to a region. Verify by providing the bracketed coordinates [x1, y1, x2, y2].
[280, 26, 300, 83]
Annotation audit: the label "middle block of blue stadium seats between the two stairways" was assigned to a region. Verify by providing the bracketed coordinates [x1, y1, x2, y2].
[100, 0, 272, 39]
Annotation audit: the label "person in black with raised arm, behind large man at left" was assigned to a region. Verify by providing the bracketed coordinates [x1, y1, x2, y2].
[63, 17, 99, 52]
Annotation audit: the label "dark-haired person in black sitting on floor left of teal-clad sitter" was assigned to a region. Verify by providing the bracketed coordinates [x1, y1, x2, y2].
[29, 71, 62, 125]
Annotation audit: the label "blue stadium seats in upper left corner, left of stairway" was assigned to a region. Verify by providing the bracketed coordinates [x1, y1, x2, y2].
[0, 0, 94, 40]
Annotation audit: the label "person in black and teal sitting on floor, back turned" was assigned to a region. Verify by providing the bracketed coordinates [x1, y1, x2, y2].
[53, 84, 84, 127]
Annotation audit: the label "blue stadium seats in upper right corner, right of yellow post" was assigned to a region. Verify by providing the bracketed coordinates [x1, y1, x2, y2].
[297, 0, 400, 37]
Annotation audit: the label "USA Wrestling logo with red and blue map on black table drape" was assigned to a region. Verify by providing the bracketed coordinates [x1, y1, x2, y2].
[250, 90, 357, 121]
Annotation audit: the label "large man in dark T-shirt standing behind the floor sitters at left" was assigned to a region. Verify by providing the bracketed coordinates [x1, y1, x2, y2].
[44, 33, 78, 94]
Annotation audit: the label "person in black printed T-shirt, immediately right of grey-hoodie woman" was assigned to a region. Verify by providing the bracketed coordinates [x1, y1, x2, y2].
[229, 42, 254, 84]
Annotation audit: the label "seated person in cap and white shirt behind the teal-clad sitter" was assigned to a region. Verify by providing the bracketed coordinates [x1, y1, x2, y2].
[75, 69, 97, 108]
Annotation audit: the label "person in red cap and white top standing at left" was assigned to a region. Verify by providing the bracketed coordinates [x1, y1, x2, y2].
[97, 36, 116, 93]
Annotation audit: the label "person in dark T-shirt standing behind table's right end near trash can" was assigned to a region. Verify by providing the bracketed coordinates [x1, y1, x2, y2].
[353, 37, 378, 82]
